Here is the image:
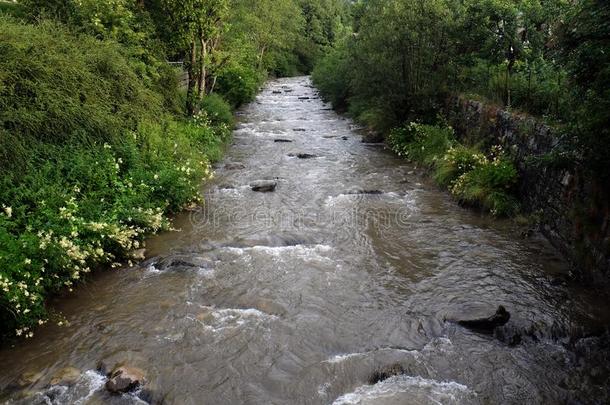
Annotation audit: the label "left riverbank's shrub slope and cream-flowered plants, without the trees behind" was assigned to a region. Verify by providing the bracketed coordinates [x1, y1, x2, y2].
[0, 16, 233, 341]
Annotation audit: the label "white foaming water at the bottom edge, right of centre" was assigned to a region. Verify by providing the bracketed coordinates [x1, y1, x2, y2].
[333, 375, 476, 405]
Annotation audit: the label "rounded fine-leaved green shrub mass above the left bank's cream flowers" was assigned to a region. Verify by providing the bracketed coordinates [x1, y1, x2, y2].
[0, 19, 164, 169]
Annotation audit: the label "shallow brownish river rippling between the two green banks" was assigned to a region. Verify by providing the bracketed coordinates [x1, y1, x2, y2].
[0, 77, 610, 404]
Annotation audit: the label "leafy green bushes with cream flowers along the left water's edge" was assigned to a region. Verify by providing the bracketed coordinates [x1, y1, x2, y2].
[0, 117, 223, 337]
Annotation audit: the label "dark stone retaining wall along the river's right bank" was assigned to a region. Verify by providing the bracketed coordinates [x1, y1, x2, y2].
[447, 97, 610, 280]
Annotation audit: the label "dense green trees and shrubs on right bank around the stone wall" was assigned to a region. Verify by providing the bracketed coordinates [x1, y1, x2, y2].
[313, 0, 610, 215]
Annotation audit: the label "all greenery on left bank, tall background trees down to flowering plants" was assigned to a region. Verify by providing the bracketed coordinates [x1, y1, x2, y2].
[0, 0, 349, 337]
